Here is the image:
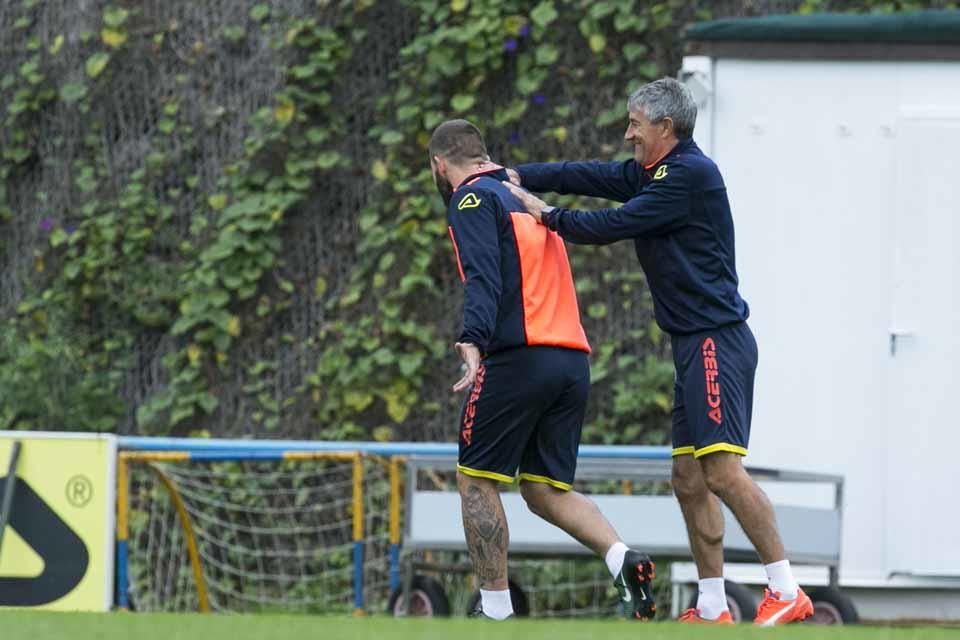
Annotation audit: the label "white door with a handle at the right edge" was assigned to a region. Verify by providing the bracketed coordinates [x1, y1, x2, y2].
[876, 113, 960, 576]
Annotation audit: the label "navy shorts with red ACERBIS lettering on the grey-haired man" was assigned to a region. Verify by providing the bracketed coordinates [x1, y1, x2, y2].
[672, 322, 757, 458]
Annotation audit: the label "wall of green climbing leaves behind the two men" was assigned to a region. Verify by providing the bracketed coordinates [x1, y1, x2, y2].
[0, 0, 954, 444]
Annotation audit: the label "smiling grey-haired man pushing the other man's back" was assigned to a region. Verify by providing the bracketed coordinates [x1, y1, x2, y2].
[508, 78, 813, 625]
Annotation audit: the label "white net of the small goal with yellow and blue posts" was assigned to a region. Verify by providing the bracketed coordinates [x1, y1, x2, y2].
[118, 453, 390, 613]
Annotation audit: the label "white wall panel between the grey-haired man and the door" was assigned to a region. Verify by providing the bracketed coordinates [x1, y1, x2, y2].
[713, 60, 899, 581]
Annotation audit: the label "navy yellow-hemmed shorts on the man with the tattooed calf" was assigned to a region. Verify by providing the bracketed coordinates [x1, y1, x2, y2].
[457, 346, 590, 491]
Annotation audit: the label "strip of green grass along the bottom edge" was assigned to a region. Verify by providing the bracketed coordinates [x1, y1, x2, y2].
[0, 611, 960, 640]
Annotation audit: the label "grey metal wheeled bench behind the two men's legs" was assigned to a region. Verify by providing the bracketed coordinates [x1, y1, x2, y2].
[397, 446, 843, 615]
